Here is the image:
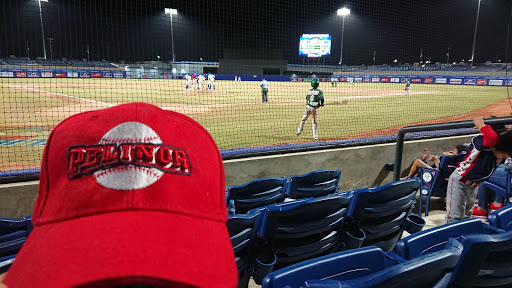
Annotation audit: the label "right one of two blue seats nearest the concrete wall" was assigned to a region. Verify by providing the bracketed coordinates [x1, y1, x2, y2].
[286, 170, 341, 199]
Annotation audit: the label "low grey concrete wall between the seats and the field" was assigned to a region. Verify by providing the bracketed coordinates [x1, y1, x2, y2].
[0, 135, 474, 217]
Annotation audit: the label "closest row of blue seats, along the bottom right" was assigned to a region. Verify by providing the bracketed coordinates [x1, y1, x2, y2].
[262, 206, 512, 288]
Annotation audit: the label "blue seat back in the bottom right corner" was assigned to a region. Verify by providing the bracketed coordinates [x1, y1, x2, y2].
[451, 231, 512, 287]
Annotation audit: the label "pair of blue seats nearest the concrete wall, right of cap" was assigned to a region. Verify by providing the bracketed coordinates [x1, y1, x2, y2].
[226, 169, 341, 214]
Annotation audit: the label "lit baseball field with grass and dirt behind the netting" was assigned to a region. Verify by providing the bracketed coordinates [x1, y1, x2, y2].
[0, 78, 511, 171]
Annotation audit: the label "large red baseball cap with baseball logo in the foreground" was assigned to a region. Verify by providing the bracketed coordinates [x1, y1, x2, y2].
[5, 103, 238, 288]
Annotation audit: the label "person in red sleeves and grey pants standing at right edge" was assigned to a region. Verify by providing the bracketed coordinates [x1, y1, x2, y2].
[446, 117, 512, 223]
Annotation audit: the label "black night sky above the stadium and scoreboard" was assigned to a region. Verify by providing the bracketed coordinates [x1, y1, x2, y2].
[0, 0, 512, 65]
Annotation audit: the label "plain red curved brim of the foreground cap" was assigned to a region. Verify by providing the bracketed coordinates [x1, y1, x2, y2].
[5, 211, 238, 288]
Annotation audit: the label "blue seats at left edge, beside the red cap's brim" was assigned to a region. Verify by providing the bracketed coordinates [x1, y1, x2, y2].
[0, 216, 33, 274]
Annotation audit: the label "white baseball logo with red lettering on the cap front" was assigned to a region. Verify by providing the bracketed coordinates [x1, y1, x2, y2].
[67, 122, 192, 190]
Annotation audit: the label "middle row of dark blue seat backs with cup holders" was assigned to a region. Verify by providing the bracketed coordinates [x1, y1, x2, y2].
[227, 178, 425, 287]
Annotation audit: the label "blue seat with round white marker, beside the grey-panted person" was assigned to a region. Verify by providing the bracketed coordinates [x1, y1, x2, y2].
[418, 153, 467, 216]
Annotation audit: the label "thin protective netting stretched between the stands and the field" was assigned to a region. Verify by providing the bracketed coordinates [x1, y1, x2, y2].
[0, 0, 512, 175]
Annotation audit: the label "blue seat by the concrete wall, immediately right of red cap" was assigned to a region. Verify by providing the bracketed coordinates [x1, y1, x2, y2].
[227, 177, 286, 214]
